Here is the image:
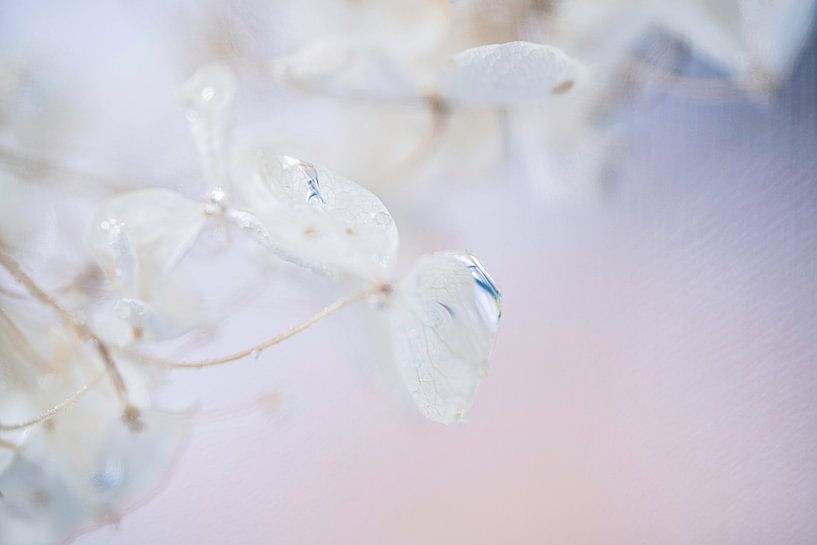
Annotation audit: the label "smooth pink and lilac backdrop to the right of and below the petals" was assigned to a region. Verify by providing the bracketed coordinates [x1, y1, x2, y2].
[1, 2, 817, 545]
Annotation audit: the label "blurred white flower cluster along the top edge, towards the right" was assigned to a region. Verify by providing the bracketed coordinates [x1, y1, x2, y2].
[273, 0, 817, 198]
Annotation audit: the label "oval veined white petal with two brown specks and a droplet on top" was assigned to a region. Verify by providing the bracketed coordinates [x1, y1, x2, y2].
[233, 150, 399, 280]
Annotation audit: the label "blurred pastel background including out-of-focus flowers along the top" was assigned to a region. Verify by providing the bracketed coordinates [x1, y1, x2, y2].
[0, 1, 817, 545]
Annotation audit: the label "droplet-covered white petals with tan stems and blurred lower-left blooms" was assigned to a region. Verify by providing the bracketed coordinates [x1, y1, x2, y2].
[0, 57, 501, 545]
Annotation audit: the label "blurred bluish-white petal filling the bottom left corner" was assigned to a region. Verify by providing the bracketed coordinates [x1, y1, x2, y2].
[0, 404, 189, 545]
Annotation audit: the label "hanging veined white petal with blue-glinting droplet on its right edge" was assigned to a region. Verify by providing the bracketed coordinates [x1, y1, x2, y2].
[390, 252, 502, 424]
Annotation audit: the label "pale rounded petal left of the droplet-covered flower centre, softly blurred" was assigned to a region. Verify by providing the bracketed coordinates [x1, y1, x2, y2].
[88, 189, 206, 298]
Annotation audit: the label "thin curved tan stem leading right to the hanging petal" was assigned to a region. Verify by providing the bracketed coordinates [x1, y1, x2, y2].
[121, 284, 391, 369]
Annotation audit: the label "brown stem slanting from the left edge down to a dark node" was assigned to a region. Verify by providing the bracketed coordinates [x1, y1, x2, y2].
[0, 251, 131, 408]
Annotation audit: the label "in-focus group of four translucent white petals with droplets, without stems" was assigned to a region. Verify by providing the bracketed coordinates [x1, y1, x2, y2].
[88, 60, 504, 424]
